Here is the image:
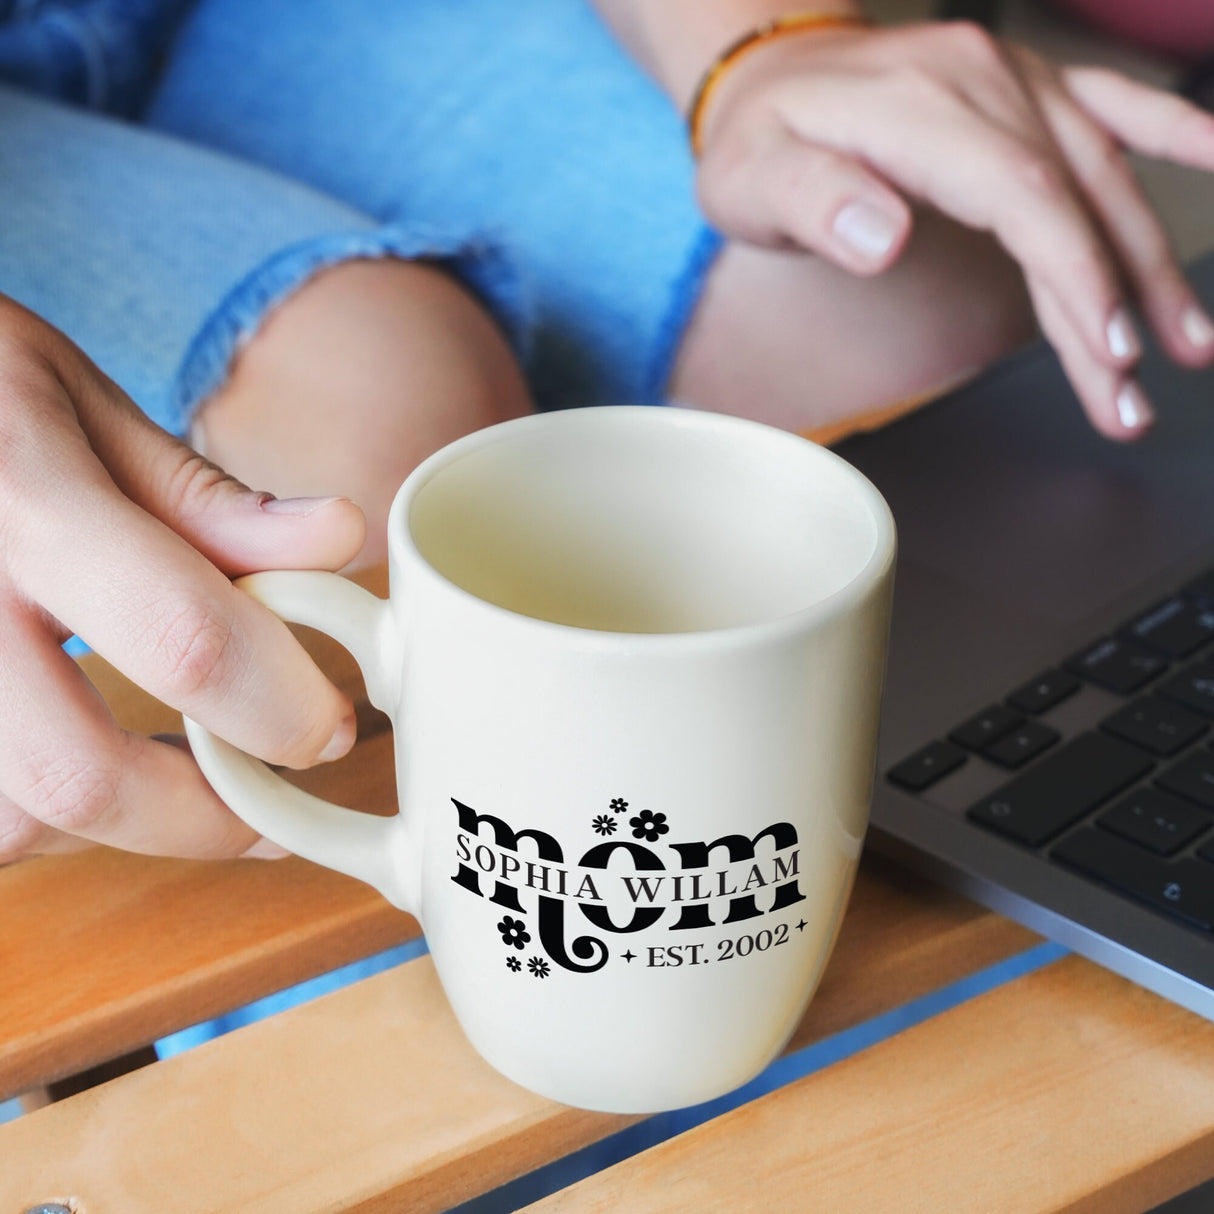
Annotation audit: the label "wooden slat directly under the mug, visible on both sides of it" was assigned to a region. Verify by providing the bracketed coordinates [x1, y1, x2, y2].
[0, 861, 1036, 1214]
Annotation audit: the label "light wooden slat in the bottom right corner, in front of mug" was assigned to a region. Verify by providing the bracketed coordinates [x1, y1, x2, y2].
[528, 958, 1214, 1214]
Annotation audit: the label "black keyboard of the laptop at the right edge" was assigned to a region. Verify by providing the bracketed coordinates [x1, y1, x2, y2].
[886, 569, 1214, 932]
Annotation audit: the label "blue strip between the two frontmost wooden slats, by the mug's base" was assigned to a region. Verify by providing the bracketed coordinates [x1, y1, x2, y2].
[448, 943, 1067, 1214]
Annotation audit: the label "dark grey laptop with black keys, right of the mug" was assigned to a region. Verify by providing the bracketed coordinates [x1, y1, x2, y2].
[836, 255, 1214, 1020]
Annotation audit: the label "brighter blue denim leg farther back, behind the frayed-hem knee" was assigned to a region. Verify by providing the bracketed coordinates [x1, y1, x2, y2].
[147, 0, 720, 407]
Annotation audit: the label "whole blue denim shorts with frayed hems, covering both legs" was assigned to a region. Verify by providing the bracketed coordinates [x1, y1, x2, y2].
[0, 0, 720, 433]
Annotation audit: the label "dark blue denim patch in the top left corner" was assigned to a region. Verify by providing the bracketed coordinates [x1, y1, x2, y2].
[0, 0, 193, 114]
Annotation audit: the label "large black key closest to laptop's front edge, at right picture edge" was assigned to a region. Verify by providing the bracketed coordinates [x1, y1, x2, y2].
[1050, 827, 1214, 931]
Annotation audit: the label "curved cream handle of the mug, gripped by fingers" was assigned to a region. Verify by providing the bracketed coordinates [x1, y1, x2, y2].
[186, 571, 416, 913]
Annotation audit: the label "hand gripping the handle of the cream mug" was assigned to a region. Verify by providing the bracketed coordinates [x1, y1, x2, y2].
[0, 297, 364, 863]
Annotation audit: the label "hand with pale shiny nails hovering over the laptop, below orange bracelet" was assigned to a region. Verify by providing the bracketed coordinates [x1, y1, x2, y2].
[698, 24, 1214, 438]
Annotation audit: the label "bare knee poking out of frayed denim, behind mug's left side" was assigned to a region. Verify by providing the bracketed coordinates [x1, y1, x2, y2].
[192, 260, 531, 565]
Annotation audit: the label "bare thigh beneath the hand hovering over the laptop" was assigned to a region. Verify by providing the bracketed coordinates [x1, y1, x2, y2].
[670, 214, 1036, 430]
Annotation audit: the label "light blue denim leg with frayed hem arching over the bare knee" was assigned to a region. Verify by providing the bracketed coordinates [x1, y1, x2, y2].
[0, 87, 529, 435]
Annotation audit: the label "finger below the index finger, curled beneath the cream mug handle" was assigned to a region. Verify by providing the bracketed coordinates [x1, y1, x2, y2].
[0, 612, 259, 857]
